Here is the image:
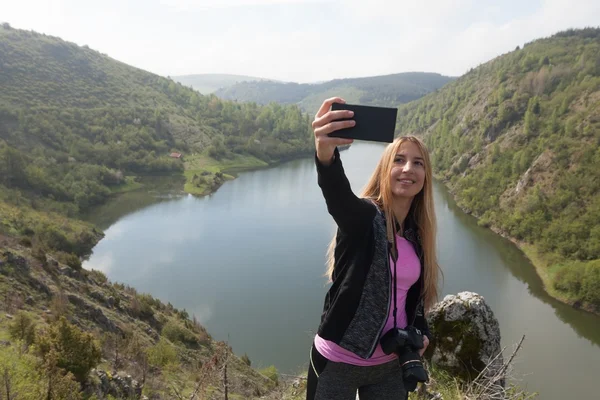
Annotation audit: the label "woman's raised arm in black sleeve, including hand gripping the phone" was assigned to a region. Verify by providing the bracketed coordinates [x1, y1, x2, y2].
[312, 97, 376, 233]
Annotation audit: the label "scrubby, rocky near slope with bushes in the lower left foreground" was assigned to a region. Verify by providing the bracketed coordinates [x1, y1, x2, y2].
[0, 235, 281, 400]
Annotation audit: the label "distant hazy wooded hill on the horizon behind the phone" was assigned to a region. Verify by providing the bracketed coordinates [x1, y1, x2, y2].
[215, 72, 453, 114]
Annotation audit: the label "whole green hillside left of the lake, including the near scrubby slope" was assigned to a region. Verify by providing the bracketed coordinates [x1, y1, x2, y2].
[0, 24, 312, 399]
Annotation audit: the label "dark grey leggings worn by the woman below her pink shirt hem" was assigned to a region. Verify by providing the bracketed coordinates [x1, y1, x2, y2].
[306, 345, 408, 400]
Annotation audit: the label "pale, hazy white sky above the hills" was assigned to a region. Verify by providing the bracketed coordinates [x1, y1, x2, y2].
[0, 0, 600, 83]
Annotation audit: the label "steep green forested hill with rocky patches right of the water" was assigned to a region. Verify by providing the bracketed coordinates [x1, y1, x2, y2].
[398, 29, 600, 310]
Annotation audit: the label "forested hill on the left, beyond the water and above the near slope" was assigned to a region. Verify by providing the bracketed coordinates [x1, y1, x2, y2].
[0, 24, 312, 222]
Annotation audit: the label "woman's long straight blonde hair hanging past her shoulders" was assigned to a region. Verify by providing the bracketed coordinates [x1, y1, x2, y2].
[326, 136, 440, 310]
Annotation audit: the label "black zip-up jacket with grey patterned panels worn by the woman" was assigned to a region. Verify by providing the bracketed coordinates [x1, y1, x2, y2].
[315, 149, 431, 359]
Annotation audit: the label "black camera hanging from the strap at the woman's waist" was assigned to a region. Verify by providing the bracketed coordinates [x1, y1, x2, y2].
[380, 326, 429, 392]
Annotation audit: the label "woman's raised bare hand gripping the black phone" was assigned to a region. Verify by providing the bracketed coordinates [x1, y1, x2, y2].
[312, 97, 356, 165]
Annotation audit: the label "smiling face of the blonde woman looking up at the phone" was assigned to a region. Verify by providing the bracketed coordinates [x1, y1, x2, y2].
[390, 142, 425, 202]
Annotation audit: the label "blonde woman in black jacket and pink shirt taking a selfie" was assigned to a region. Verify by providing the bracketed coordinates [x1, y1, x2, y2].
[307, 97, 439, 400]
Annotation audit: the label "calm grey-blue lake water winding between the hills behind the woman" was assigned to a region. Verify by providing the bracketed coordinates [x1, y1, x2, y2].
[84, 143, 600, 399]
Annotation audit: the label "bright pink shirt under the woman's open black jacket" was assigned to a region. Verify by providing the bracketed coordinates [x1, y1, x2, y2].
[315, 235, 421, 366]
